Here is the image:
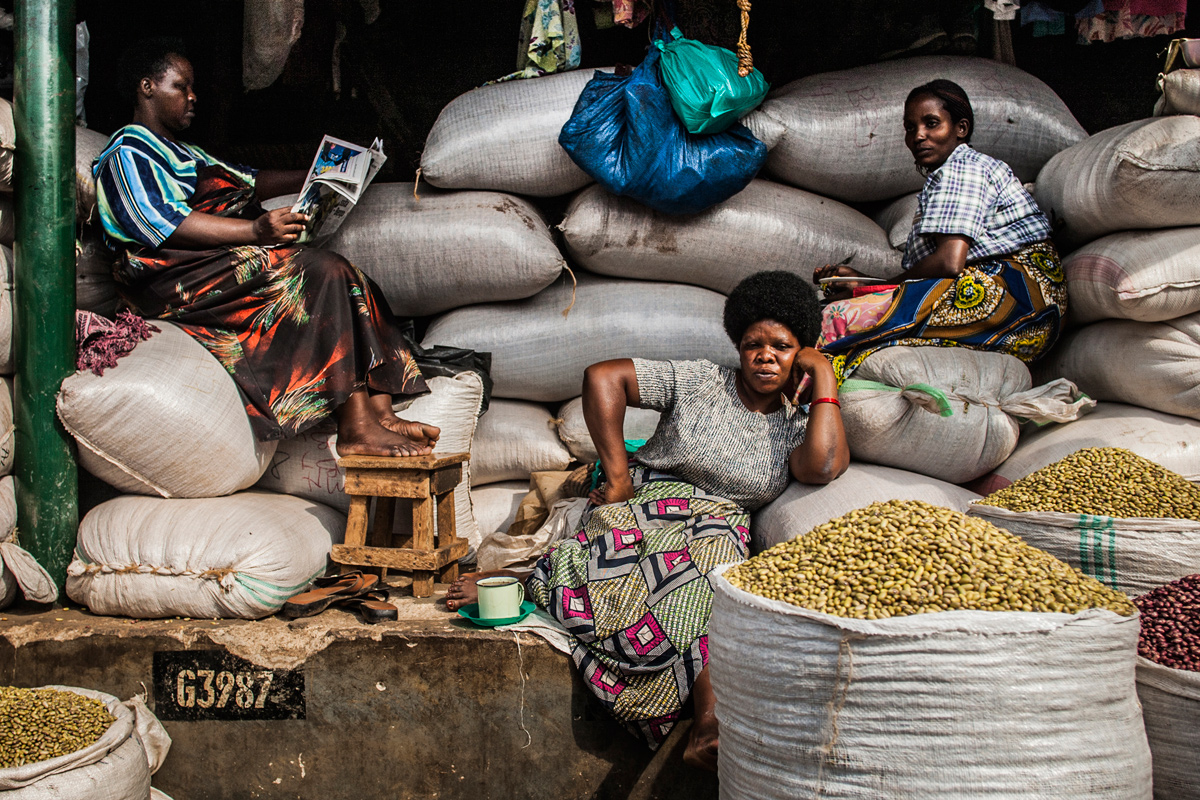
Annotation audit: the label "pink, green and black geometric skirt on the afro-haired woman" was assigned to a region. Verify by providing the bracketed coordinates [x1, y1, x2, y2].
[528, 463, 750, 750]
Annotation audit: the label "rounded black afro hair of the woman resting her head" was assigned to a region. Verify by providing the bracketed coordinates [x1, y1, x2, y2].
[725, 270, 821, 347]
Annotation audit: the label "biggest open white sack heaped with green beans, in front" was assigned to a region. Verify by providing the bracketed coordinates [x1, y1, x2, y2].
[708, 501, 1151, 800]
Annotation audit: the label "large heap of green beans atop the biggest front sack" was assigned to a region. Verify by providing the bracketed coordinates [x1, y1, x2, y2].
[725, 500, 1134, 619]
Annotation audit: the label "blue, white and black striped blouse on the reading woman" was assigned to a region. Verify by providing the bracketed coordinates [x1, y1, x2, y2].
[91, 125, 257, 247]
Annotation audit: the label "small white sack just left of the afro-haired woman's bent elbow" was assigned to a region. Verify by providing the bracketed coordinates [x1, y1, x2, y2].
[470, 399, 571, 486]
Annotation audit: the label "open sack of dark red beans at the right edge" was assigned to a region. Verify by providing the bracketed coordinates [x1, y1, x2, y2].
[1134, 575, 1200, 800]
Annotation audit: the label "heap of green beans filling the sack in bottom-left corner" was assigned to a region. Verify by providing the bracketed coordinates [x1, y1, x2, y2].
[0, 686, 115, 769]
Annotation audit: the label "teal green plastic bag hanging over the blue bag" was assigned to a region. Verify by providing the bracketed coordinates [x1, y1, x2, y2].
[654, 28, 770, 133]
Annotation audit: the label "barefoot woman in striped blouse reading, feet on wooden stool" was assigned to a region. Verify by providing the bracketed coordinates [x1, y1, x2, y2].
[92, 40, 439, 456]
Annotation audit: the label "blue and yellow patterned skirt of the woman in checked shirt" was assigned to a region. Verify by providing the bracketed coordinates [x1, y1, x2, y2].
[820, 241, 1067, 384]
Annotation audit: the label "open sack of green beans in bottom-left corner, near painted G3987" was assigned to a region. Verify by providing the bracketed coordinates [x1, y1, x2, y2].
[0, 686, 170, 800]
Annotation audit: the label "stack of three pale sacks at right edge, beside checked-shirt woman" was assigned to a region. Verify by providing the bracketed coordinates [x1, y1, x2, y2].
[1037, 116, 1200, 420]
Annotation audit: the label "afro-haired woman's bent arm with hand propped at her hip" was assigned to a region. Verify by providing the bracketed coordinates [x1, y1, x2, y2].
[583, 359, 642, 505]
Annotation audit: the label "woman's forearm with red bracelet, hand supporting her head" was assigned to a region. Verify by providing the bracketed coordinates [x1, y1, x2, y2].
[788, 348, 850, 483]
